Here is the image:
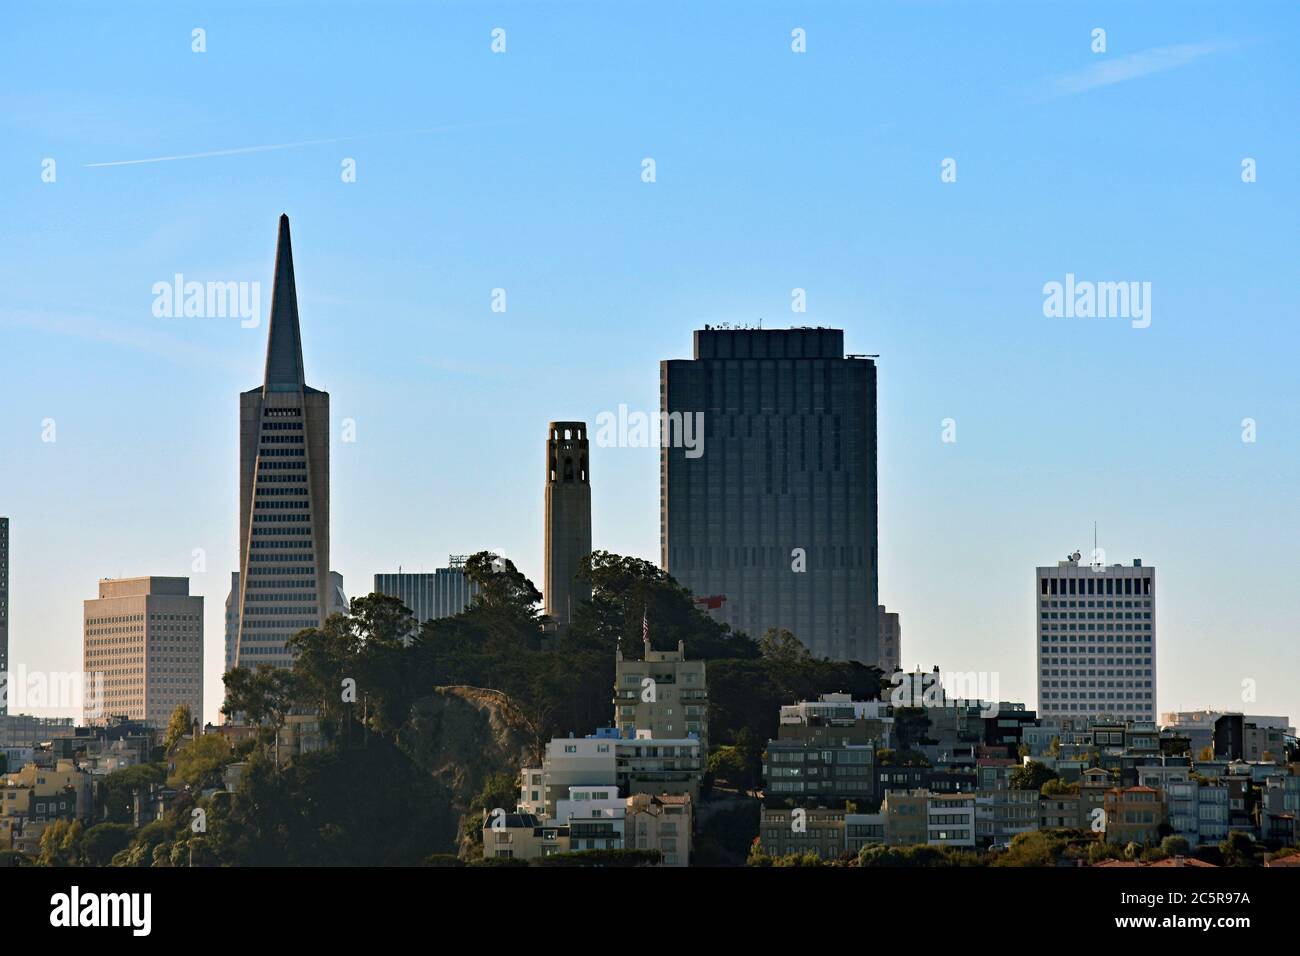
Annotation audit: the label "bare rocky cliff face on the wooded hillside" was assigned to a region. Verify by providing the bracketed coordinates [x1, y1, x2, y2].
[402, 685, 533, 857]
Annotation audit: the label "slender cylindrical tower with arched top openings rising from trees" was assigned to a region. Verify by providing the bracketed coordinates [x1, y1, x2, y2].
[542, 421, 592, 624]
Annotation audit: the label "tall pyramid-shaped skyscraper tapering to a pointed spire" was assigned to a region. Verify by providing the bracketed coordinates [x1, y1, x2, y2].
[234, 216, 333, 667]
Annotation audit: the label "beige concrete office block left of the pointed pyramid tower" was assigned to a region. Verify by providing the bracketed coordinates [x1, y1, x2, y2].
[83, 578, 203, 727]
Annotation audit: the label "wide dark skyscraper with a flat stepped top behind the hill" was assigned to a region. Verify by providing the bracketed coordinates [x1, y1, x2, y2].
[659, 326, 880, 665]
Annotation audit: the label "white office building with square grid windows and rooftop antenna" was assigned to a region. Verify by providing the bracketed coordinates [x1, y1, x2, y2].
[1034, 551, 1156, 721]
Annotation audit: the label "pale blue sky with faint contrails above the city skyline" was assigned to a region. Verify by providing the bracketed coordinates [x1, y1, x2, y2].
[0, 1, 1300, 718]
